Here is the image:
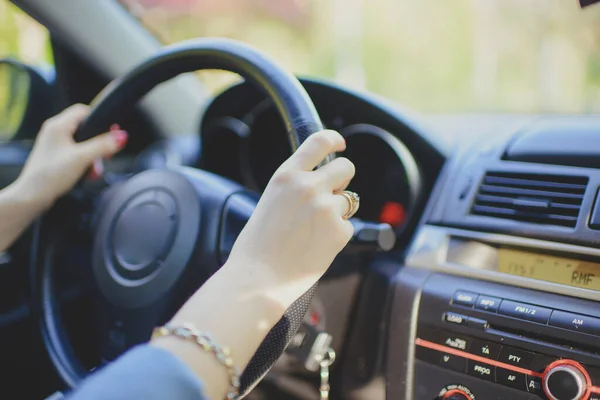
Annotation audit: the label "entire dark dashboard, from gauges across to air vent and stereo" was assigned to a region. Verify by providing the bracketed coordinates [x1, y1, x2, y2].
[200, 80, 600, 400]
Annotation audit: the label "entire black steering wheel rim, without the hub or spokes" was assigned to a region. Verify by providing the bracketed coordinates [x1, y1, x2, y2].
[32, 39, 329, 394]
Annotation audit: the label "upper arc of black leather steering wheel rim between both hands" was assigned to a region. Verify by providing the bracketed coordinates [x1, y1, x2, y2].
[77, 38, 323, 150]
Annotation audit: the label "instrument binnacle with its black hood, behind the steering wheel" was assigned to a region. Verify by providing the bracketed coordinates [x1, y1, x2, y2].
[200, 76, 444, 245]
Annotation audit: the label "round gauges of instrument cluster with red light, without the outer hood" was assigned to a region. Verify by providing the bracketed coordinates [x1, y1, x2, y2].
[199, 79, 423, 239]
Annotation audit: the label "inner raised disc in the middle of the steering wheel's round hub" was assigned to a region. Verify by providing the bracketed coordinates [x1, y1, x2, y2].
[109, 189, 179, 280]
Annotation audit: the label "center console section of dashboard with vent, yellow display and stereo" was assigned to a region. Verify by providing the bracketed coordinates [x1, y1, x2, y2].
[386, 116, 600, 400]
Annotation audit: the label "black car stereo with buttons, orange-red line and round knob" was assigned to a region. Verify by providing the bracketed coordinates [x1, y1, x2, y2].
[414, 273, 600, 400]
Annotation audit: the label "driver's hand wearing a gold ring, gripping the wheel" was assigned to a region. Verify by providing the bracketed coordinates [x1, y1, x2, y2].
[227, 130, 355, 294]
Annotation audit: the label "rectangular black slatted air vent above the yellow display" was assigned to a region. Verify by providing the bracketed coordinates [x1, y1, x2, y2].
[471, 172, 588, 227]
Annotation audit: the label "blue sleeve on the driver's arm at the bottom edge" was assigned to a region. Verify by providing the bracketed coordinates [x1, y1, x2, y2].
[67, 345, 206, 400]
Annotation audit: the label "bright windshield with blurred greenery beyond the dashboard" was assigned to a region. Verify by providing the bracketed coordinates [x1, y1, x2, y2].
[121, 0, 600, 113]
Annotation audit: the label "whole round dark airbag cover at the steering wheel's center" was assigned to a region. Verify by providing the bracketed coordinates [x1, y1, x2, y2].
[92, 170, 202, 309]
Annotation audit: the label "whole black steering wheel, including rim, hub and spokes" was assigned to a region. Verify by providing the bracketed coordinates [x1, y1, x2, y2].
[32, 39, 328, 393]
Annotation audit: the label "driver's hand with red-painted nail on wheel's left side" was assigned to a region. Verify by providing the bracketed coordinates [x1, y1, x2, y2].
[16, 104, 127, 211]
